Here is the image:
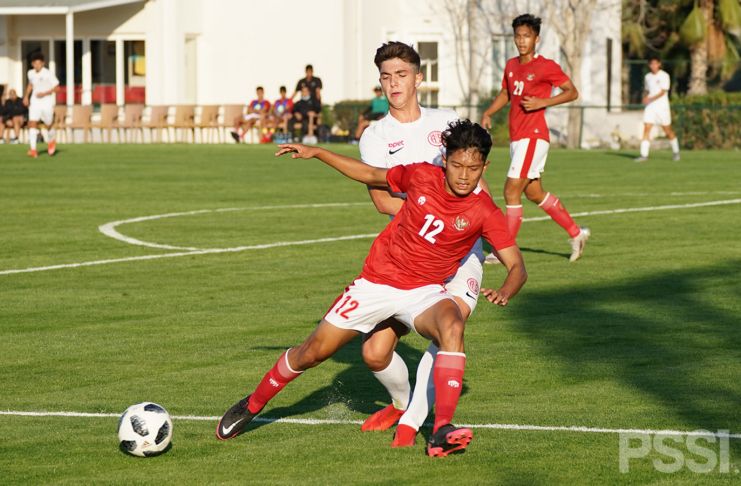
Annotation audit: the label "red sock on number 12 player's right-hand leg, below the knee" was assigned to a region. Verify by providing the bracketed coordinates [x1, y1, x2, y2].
[432, 351, 466, 433]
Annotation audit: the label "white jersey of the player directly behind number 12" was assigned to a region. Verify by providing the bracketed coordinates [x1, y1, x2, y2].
[360, 107, 458, 169]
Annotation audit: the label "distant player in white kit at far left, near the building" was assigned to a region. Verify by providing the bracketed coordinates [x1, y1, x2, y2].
[23, 52, 59, 158]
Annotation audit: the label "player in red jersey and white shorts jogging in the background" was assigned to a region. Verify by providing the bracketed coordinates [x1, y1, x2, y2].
[481, 14, 590, 262]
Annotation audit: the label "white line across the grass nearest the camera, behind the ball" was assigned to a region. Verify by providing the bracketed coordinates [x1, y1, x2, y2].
[0, 410, 741, 439]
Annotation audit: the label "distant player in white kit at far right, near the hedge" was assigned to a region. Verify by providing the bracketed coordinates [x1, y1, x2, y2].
[635, 57, 679, 162]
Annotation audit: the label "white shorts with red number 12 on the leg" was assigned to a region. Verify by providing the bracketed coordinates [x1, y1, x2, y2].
[324, 278, 453, 333]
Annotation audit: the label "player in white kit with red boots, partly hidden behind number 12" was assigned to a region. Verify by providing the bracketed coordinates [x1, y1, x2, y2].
[360, 42, 484, 447]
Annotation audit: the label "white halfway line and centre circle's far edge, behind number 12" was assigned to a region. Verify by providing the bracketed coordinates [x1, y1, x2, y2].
[0, 199, 741, 275]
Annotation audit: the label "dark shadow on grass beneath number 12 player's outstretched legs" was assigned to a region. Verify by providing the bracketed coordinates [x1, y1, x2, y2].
[245, 336, 467, 432]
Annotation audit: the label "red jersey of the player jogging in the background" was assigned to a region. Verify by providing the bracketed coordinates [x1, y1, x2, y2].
[502, 54, 569, 142]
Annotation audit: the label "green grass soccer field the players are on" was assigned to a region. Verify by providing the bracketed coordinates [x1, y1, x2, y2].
[0, 145, 741, 484]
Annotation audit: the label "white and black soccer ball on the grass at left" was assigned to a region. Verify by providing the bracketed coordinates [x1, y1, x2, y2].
[118, 402, 172, 457]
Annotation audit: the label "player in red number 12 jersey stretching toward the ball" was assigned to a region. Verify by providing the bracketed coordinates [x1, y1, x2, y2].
[216, 120, 527, 456]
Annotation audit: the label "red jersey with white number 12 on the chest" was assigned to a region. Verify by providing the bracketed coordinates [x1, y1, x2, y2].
[360, 163, 515, 289]
